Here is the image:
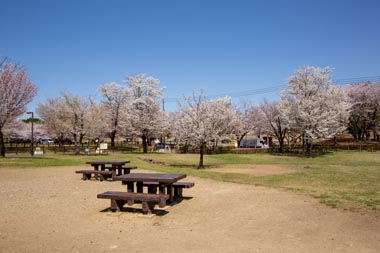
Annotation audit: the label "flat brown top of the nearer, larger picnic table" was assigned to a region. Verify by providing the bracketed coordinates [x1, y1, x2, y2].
[114, 173, 186, 183]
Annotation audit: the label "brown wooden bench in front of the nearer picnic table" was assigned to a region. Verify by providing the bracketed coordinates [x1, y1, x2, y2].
[98, 191, 169, 214]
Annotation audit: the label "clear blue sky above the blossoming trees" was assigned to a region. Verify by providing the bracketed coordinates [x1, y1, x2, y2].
[0, 0, 380, 110]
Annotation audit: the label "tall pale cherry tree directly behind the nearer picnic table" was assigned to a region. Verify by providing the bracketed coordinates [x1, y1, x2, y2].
[124, 74, 164, 153]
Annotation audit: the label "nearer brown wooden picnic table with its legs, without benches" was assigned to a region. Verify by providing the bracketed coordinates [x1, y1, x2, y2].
[114, 173, 186, 202]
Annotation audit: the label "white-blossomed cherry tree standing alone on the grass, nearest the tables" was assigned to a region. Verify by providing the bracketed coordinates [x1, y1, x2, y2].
[172, 92, 236, 168]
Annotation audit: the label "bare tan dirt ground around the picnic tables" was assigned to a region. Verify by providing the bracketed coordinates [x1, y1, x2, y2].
[0, 166, 380, 252]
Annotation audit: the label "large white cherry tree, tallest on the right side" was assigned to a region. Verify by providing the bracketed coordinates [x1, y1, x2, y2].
[281, 66, 350, 155]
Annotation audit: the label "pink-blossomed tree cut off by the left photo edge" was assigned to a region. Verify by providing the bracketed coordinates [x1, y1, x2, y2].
[0, 59, 37, 157]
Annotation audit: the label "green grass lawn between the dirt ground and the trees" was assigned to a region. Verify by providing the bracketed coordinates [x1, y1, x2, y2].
[0, 152, 380, 212]
